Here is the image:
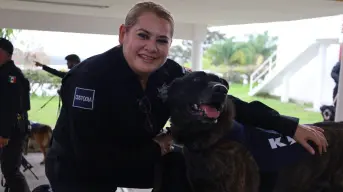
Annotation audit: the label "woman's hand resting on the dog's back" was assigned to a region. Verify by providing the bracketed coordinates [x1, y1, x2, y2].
[294, 125, 328, 155]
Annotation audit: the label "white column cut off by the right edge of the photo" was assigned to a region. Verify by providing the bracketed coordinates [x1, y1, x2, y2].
[335, 43, 343, 121]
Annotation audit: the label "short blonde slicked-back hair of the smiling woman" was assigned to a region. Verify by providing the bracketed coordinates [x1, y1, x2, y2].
[125, 1, 174, 36]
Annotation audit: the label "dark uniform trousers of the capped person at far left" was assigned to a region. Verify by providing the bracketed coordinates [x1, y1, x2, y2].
[0, 115, 30, 192]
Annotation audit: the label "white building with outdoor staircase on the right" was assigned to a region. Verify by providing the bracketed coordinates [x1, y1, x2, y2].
[250, 16, 342, 110]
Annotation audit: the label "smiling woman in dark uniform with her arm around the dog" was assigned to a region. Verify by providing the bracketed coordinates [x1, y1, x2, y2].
[46, 2, 327, 192]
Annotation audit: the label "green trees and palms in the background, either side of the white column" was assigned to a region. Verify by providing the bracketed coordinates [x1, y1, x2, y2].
[169, 31, 278, 66]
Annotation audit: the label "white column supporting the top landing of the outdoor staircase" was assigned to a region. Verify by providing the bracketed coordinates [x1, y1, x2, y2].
[313, 44, 328, 111]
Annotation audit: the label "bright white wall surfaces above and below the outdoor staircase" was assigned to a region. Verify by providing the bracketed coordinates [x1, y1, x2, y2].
[271, 16, 342, 104]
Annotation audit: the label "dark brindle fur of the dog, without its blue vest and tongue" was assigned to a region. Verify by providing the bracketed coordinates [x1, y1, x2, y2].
[167, 72, 343, 192]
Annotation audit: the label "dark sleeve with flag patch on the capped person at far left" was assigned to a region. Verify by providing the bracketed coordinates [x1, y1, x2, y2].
[0, 75, 20, 138]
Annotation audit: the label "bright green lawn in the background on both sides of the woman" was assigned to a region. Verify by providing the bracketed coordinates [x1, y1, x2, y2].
[29, 85, 322, 126]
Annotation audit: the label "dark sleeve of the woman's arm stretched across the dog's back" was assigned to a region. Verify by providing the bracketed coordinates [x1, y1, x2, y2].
[228, 95, 299, 136]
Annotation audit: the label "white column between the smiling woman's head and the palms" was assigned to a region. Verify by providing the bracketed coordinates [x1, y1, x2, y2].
[191, 24, 207, 71]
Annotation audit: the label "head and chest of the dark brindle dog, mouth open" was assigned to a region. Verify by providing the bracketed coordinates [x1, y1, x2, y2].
[167, 72, 259, 192]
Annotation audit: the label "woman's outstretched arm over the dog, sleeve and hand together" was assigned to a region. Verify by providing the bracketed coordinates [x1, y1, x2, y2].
[228, 95, 328, 154]
